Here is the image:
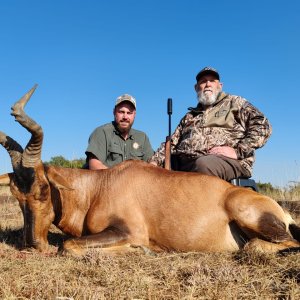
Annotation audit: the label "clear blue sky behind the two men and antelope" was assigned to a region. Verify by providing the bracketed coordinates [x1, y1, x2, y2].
[0, 0, 300, 186]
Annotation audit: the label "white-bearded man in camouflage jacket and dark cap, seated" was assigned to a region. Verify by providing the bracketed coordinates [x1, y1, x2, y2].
[150, 67, 272, 181]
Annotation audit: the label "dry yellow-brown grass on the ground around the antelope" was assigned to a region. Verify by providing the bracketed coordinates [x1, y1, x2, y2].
[0, 188, 300, 300]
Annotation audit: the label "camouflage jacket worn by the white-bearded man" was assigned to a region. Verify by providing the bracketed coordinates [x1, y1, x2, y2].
[150, 92, 272, 175]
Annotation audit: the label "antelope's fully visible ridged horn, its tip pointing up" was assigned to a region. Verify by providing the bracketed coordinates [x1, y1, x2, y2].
[11, 84, 44, 168]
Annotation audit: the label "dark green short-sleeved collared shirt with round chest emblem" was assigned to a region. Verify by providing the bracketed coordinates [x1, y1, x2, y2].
[85, 122, 154, 167]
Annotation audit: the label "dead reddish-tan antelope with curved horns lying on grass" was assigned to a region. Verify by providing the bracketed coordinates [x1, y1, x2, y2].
[0, 87, 300, 254]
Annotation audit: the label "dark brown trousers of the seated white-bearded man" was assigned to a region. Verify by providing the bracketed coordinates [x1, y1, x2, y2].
[172, 155, 251, 181]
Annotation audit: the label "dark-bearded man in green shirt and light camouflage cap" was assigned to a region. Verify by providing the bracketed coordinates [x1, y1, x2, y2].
[85, 94, 154, 170]
